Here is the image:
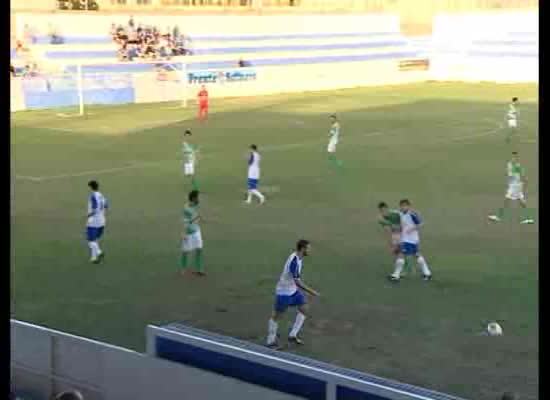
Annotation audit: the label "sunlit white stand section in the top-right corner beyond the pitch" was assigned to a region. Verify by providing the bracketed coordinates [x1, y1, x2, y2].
[430, 11, 539, 82]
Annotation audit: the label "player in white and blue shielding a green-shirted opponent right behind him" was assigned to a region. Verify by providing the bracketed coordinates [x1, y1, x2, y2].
[390, 199, 432, 282]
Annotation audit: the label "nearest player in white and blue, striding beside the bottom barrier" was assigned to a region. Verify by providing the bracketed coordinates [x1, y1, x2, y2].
[267, 239, 320, 347]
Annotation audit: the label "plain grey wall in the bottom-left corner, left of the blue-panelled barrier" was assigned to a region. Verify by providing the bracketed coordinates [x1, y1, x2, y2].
[10, 320, 298, 400]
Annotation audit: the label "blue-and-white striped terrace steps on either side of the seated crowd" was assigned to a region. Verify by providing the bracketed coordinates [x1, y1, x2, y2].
[12, 32, 417, 71]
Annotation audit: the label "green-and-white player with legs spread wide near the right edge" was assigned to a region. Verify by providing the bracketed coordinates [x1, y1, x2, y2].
[489, 151, 535, 224]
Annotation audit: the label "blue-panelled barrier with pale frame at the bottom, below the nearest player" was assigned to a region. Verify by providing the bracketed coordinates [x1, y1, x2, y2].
[147, 323, 466, 400]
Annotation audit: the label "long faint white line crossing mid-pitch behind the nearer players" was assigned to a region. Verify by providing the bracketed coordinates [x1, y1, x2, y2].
[15, 127, 502, 183]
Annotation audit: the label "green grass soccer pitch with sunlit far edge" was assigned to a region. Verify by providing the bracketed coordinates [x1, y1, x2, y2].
[11, 83, 538, 400]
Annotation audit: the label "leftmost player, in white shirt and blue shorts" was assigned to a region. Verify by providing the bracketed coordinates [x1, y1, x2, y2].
[86, 181, 109, 264]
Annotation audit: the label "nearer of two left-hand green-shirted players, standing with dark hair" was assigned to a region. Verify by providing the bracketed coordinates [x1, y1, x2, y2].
[181, 190, 205, 276]
